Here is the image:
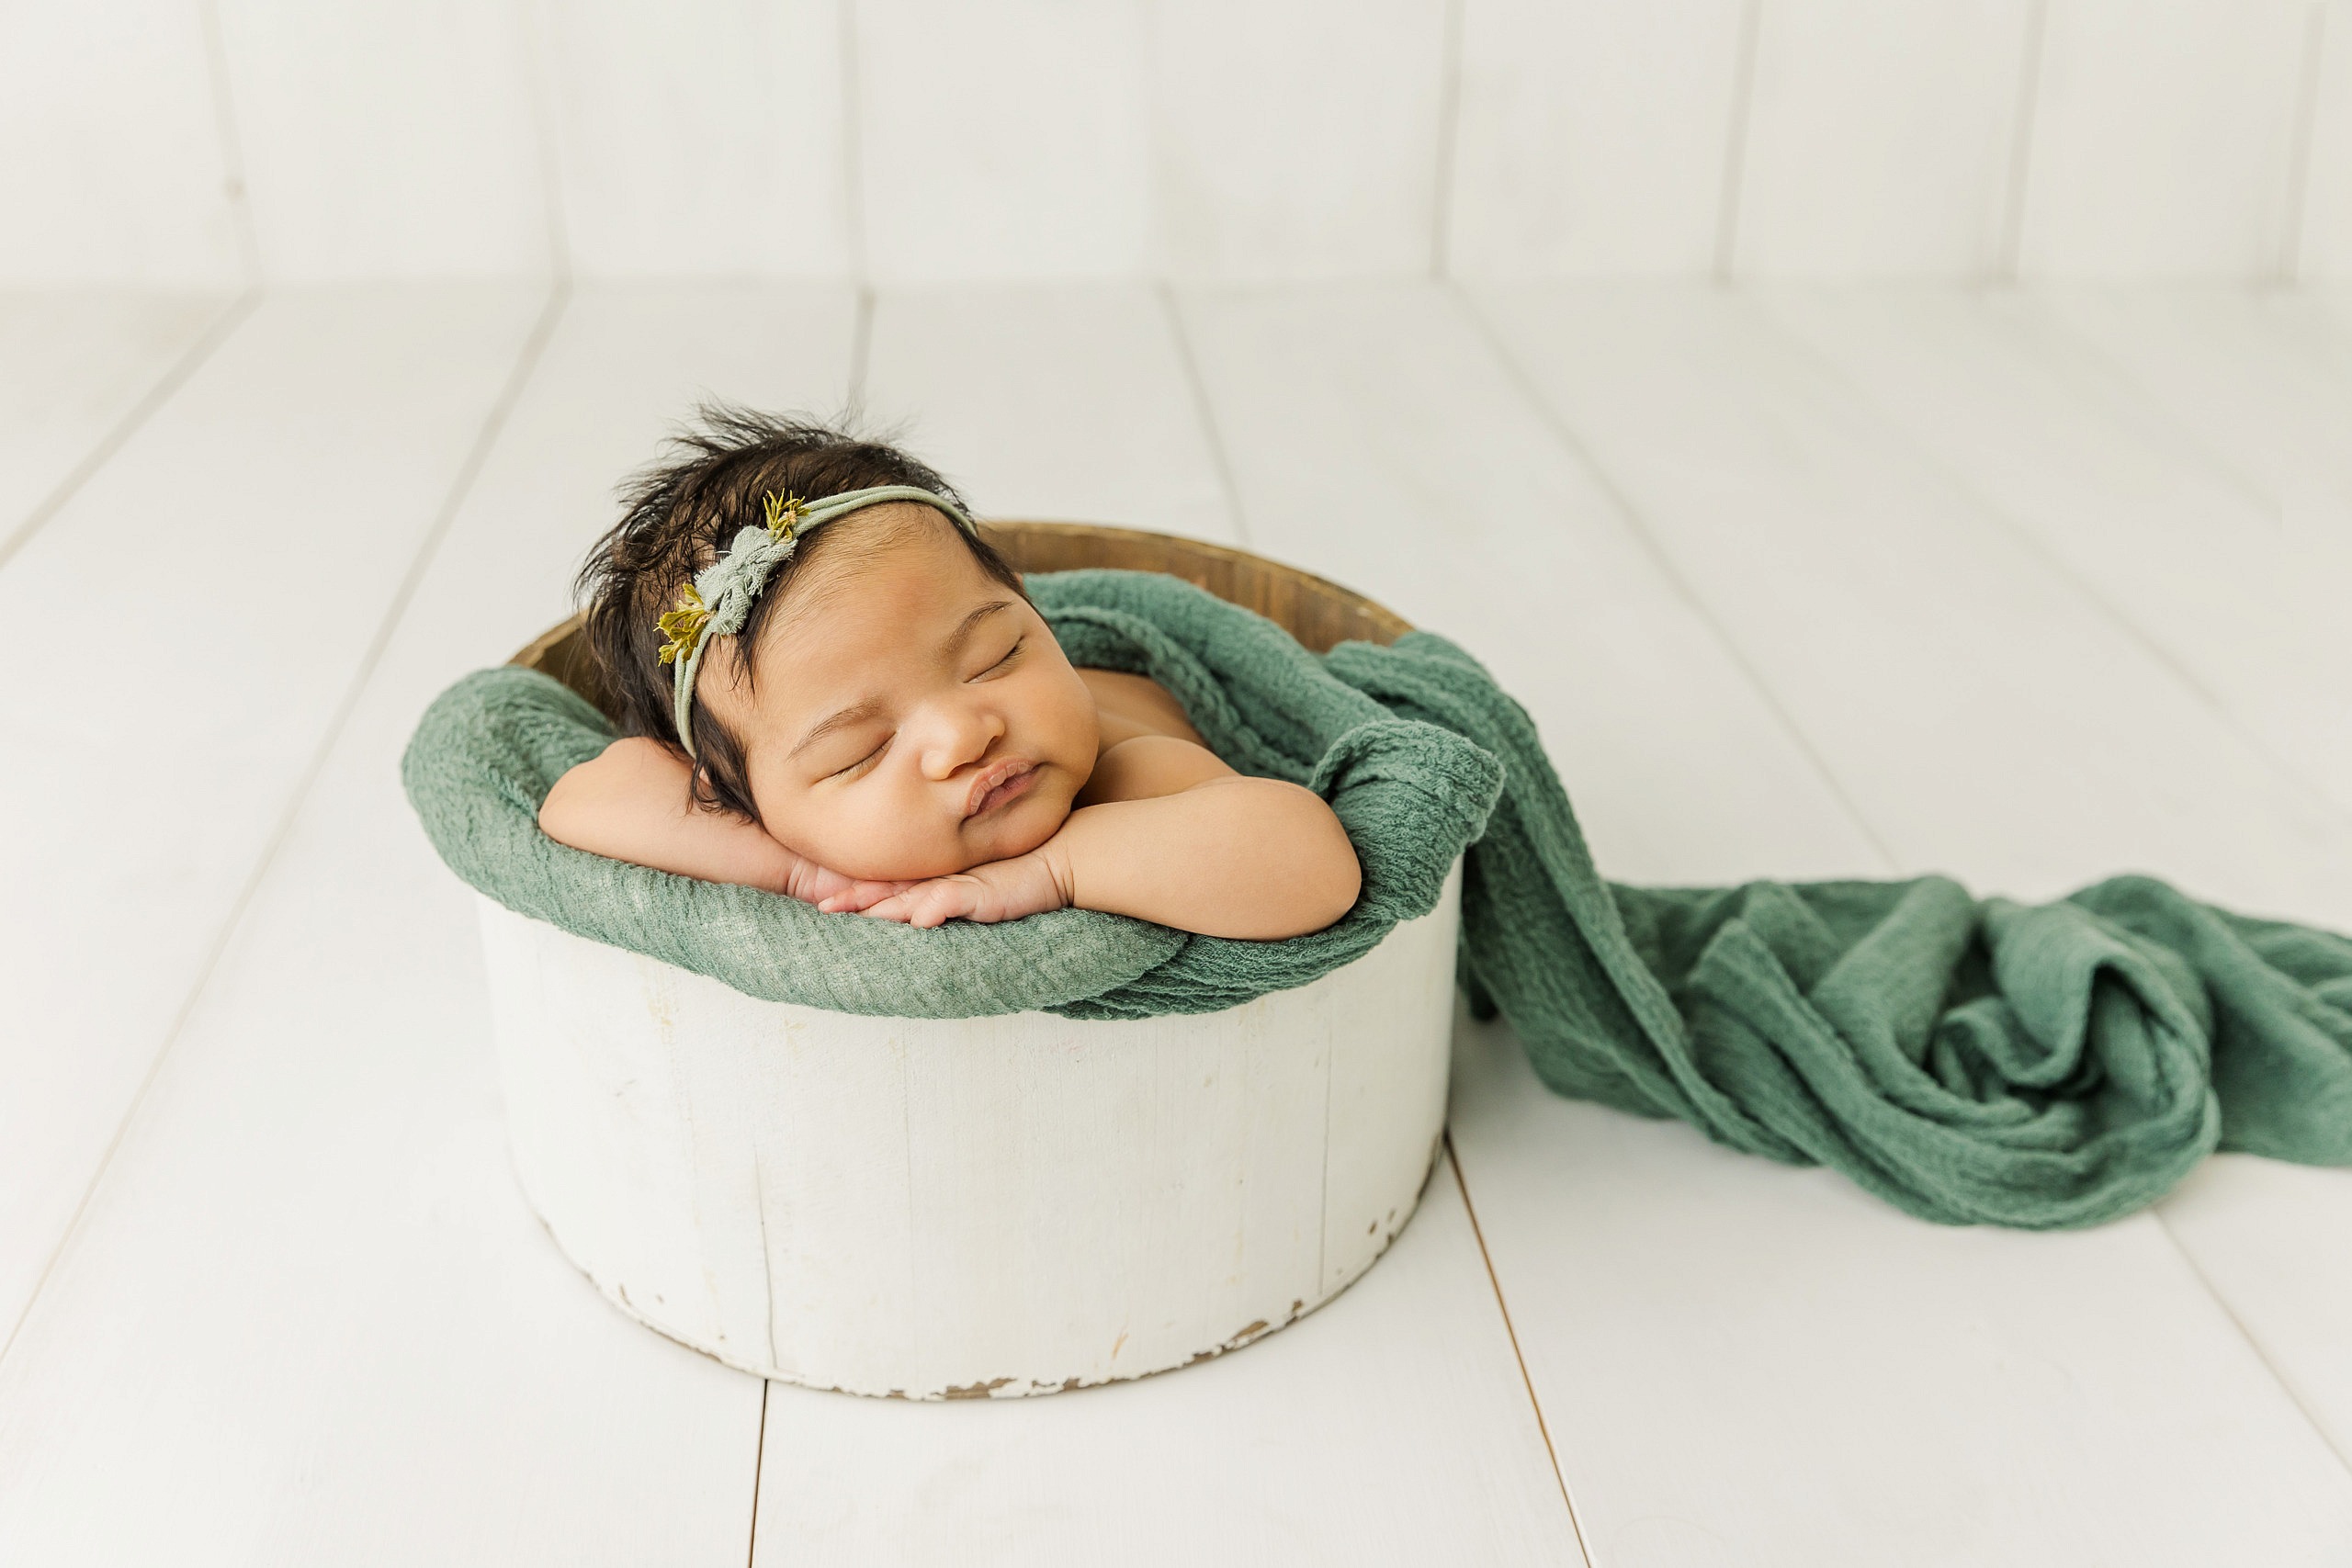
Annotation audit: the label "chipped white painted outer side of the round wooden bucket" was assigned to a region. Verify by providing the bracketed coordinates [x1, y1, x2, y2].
[480, 865, 1461, 1399]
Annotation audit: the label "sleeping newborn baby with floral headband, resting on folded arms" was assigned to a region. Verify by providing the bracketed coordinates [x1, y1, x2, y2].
[538, 409, 1360, 938]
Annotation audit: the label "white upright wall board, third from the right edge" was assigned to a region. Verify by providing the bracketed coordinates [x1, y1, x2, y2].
[1731, 0, 2037, 280]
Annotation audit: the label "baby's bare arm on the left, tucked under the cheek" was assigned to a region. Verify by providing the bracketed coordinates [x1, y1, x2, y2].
[538, 736, 903, 903]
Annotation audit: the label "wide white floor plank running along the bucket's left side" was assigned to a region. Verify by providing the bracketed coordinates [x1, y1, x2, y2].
[0, 287, 854, 1565]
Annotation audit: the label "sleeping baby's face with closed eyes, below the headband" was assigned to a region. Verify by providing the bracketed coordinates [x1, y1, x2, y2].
[698, 503, 1099, 879]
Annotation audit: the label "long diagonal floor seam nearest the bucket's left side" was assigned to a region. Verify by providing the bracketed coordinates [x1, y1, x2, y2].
[0, 285, 570, 1363]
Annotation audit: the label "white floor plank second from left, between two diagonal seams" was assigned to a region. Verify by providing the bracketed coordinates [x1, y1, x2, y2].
[0, 285, 541, 1324]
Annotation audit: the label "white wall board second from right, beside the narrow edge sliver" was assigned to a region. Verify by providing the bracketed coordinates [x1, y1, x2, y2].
[2018, 0, 2310, 280]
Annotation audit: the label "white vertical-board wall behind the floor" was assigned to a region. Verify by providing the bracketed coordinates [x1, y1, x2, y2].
[0, 0, 2352, 287]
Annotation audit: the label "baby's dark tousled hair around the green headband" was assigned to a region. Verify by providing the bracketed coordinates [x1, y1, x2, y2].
[576, 402, 1028, 823]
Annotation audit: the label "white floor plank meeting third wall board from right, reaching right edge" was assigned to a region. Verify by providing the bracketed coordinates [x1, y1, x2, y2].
[1773, 291, 2352, 818]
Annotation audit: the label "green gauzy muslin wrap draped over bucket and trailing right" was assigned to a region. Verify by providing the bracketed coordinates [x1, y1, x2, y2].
[402, 571, 2352, 1229]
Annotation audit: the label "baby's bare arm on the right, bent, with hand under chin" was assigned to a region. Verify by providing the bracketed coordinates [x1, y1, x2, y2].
[842, 736, 1362, 941]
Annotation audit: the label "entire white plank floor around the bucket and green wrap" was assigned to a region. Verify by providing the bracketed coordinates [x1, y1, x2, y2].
[0, 285, 2352, 1568]
